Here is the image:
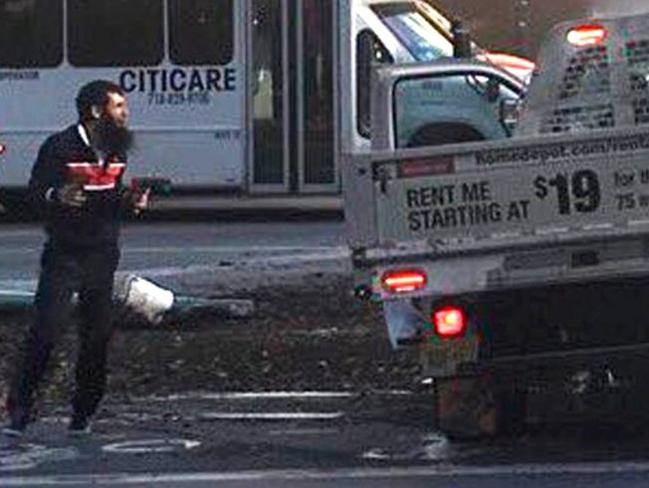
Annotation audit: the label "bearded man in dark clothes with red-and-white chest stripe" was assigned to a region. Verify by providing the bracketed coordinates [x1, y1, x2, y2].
[3, 80, 148, 437]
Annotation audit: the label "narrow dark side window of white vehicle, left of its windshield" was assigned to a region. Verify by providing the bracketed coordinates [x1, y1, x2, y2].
[356, 29, 394, 138]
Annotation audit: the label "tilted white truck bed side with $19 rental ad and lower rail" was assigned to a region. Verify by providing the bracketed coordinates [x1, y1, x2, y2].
[346, 128, 649, 297]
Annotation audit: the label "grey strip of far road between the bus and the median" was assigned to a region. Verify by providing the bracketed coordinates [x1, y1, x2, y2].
[0, 222, 345, 289]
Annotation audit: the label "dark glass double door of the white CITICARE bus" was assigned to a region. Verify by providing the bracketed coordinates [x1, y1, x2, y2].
[250, 0, 338, 193]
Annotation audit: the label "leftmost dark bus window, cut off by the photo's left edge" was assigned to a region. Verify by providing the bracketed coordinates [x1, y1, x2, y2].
[0, 0, 63, 68]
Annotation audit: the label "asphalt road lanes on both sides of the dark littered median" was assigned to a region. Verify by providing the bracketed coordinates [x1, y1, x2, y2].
[0, 222, 649, 488]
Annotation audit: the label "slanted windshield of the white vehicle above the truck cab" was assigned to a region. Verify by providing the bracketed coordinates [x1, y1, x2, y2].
[372, 1, 453, 61]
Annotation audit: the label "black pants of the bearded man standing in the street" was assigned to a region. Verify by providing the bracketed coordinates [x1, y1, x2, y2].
[7, 241, 119, 425]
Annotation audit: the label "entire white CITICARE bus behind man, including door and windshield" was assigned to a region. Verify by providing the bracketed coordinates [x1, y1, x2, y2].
[0, 0, 528, 208]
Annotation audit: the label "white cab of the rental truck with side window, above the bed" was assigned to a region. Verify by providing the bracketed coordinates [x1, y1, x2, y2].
[372, 59, 526, 150]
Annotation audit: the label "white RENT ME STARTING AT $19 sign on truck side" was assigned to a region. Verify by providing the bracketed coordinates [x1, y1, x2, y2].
[376, 131, 649, 240]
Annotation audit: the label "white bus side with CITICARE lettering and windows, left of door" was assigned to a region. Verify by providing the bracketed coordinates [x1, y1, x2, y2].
[0, 0, 247, 200]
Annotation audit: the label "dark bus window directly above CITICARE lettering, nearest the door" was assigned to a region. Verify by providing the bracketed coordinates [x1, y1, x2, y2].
[169, 0, 234, 66]
